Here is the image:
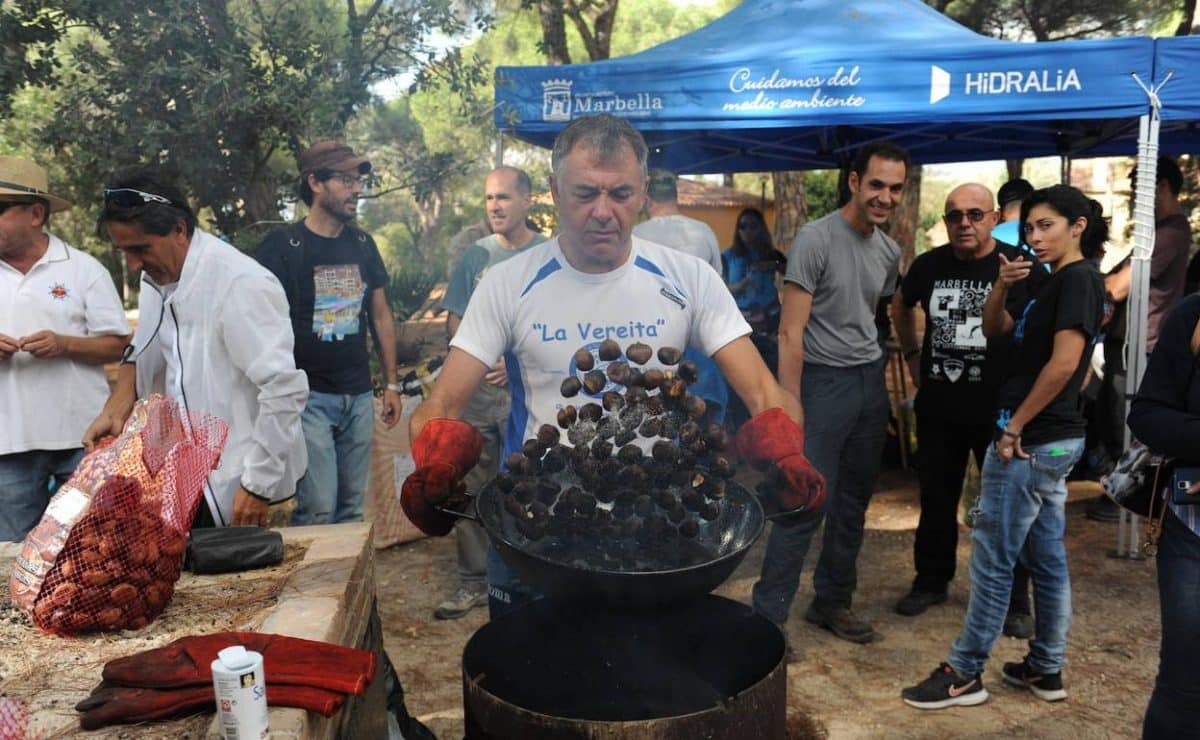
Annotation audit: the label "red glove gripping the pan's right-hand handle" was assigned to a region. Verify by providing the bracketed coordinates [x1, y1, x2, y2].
[737, 407, 826, 511]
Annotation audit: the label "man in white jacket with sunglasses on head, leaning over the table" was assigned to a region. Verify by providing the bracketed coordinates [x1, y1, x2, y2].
[83, 168, 308, 527]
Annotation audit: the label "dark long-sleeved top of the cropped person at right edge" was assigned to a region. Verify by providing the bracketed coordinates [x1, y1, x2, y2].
[1129, 295, 1200, 462]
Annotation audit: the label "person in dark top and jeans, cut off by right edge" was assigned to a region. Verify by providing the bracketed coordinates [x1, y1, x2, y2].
[1129, 295, 1200, 740]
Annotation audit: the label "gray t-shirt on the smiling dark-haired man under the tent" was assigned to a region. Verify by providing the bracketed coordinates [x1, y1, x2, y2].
[784, 211, 900, 367]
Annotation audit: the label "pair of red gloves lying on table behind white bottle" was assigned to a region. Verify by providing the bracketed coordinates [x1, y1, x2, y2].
[76, 632, 376, 730]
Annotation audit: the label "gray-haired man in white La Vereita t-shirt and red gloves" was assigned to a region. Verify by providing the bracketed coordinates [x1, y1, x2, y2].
[401, 115, 824, 616]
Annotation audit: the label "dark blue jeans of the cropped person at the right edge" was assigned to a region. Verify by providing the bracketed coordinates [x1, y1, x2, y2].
[1141, 511, 1200, 740]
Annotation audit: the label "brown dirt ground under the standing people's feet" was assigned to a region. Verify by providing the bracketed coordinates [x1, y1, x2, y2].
[377, 471, 1158, 740]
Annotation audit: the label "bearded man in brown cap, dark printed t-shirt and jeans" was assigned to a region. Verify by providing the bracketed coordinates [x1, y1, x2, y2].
[257, 140, 401, 524]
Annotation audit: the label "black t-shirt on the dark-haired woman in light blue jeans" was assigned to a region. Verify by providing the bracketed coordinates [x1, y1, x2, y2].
[996, 259, 1104, 446]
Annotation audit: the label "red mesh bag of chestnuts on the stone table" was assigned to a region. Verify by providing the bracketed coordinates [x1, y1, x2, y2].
[8, 396, 228, 634]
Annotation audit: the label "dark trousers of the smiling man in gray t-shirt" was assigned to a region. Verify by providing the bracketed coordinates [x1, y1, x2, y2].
[754, 357, 889, 624]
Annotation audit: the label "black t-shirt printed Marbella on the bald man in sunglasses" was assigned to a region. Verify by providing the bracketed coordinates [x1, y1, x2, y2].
[901, 241, 1049, 423]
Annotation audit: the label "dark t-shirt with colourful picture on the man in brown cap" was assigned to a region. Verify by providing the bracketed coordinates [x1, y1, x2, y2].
[258, 222, 388, 393]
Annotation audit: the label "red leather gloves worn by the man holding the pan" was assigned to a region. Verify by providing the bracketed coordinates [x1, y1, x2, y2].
[400, 408, 826, 537]
